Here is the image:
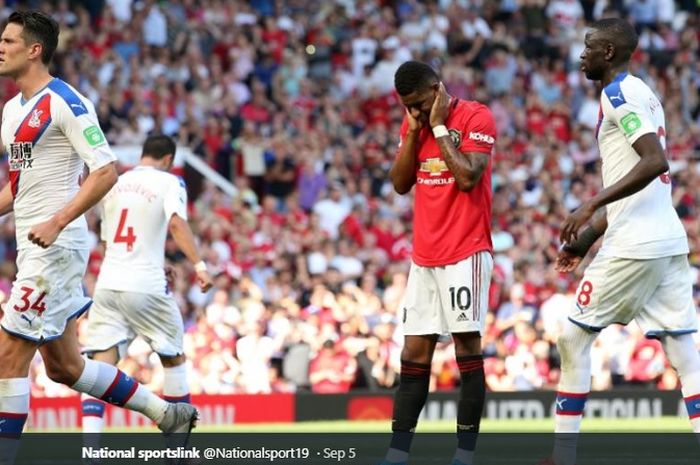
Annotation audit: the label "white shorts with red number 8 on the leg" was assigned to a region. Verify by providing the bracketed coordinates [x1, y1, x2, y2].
[569, 255, 697, 337]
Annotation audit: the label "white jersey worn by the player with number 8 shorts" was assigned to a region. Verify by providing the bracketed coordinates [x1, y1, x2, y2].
[597, 73, 688, 259]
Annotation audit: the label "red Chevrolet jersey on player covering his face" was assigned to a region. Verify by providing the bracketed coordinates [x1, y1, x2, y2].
[401, 98, 496, 266]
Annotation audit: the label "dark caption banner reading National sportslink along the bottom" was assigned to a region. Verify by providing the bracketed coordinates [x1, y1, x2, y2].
[5, 433, 700, 465]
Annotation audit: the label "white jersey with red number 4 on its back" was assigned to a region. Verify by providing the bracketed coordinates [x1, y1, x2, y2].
[96, 166, 187, 294]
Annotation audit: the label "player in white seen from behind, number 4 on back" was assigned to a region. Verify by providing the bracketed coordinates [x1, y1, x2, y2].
[83, 135, 212, 442]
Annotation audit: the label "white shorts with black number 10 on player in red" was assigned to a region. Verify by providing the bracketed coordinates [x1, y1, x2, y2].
[399, 251, 493, 336]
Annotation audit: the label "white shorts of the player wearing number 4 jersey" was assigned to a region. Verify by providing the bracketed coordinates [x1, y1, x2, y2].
[83, 289, 184, 358]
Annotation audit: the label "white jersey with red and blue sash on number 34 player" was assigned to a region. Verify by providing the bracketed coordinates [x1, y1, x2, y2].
[0, 78, 116, 249]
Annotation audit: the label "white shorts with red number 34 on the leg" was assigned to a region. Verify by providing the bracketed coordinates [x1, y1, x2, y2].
[0, 246, 92, 343]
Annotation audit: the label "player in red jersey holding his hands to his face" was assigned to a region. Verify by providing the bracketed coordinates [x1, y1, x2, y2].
[385, 61, 496, 465]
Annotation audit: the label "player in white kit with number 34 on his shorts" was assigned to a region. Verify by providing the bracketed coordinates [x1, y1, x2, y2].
[0, 11, 196, 464]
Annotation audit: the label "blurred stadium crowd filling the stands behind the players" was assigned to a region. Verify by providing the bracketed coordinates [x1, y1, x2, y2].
[0, 0, 700, 396]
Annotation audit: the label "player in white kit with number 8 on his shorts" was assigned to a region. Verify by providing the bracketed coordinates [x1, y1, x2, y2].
[543, 18, 700, 465]
